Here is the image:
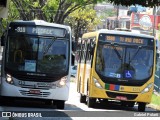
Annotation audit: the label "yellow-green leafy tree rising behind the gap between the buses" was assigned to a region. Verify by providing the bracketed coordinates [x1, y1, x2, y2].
[65, 5, 100, 41]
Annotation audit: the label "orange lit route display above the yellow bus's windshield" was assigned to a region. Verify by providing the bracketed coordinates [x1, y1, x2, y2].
[106, 35, 145, 44]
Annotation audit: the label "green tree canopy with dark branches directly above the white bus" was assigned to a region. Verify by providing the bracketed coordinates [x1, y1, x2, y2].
[12, 0, 105, 24]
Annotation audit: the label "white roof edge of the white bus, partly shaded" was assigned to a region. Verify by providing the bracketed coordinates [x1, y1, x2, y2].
[10, 20, 70, 29]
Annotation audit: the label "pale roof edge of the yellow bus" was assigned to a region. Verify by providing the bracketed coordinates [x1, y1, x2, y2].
[82, 29, 154, 39]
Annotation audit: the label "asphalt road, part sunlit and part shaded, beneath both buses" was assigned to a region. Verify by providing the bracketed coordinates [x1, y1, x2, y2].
[0, 82, 160, 120]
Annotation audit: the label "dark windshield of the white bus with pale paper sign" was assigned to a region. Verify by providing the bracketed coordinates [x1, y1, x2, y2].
[6, 36, 69, 74]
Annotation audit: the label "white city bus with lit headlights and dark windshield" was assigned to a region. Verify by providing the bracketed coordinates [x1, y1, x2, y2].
[0, 20, 72, 109]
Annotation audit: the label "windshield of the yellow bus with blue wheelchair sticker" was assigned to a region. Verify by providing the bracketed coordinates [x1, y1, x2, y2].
[96, 42, 154, 80]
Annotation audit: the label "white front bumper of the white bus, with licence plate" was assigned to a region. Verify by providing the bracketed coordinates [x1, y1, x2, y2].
[0, 81, 69, 101]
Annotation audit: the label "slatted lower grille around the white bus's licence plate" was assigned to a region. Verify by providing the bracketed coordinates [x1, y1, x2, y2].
[20, 90, 51, 97]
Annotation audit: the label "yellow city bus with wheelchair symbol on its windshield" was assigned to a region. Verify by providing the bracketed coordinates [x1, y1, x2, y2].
[77, 29, 156, 111]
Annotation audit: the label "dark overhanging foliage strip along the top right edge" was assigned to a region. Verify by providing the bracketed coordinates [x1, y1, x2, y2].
[107, 0, 160, 7]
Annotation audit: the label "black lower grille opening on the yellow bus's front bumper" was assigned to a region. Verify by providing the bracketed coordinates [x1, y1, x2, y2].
[106, 91, 138, 100]
